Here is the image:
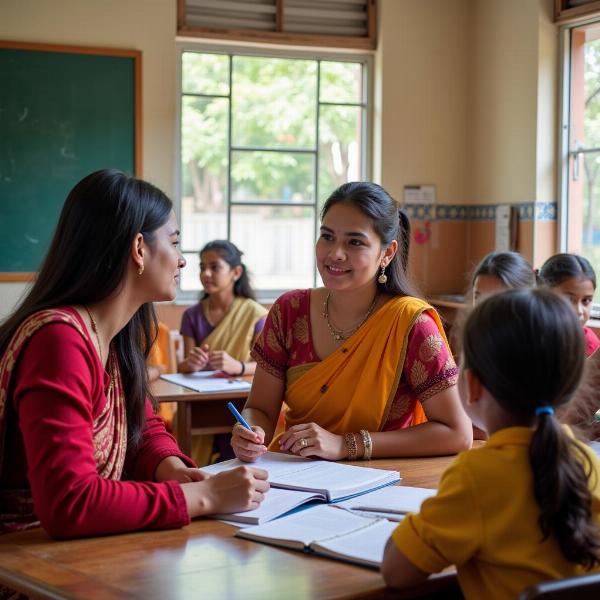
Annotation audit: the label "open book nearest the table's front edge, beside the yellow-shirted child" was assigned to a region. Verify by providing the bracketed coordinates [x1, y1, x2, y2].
[235, 505, 397, 568]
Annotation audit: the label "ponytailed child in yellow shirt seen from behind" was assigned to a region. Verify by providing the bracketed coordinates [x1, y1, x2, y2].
[382, 289, 600, 600]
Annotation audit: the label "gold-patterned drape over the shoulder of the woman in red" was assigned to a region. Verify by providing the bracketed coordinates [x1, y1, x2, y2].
[0, 309, 127, 534]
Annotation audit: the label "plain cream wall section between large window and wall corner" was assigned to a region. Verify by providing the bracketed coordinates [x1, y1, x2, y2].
[375, 0, 469, 204]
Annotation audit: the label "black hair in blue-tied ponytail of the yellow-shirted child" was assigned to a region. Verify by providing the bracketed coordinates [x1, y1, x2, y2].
[463, 289, 600, 569]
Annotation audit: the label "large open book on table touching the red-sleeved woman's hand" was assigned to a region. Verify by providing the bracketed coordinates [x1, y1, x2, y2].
[202, 452, 400, 523]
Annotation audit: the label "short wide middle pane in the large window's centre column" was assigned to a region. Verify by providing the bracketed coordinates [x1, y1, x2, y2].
[231, 151, 315, 204]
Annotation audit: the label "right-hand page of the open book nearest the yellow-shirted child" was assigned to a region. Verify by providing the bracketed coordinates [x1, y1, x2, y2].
[311, 519, 397, 567]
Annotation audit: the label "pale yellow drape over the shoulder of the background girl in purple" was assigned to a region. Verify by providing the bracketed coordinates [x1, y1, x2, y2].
[202, 296, 267, 362]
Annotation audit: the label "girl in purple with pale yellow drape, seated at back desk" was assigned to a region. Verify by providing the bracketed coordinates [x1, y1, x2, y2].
[179, 240, 267, 376]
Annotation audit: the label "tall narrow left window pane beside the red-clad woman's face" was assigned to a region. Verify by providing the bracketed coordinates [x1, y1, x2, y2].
[181, 96, 229, 262]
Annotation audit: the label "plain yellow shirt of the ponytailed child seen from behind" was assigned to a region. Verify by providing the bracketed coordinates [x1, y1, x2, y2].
[392, 427, 600, 600]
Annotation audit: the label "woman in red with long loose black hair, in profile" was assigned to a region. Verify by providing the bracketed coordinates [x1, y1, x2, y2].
[0, 170, 268, 538]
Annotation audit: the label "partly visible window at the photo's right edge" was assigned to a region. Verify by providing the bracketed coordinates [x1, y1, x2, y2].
[561, 22, 600, 305]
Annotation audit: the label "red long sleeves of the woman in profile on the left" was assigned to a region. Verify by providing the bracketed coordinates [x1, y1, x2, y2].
[12, 324, 189, 538]
